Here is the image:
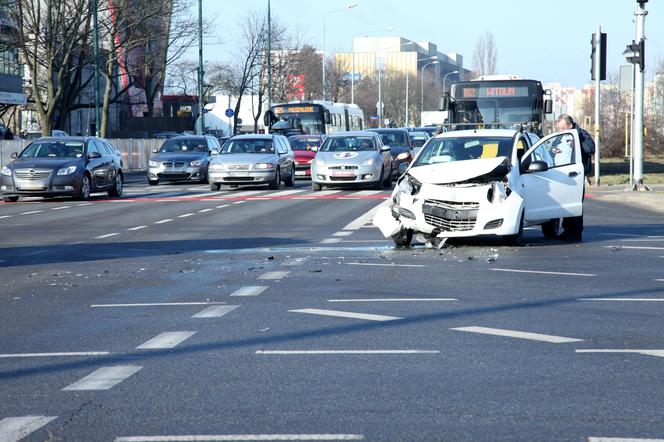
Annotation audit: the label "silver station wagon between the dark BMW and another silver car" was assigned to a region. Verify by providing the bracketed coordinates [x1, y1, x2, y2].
[208, 134, 295, 190]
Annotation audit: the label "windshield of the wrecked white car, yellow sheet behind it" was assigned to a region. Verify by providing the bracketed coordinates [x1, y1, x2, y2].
[413, 137, 514, 167]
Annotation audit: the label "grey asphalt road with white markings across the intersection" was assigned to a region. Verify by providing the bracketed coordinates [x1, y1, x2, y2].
[0, 179, 664, 442]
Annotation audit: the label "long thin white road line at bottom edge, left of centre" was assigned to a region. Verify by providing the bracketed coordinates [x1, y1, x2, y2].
[115, 434, 364, 442]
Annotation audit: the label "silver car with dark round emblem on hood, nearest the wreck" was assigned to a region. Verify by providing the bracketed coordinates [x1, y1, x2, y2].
[311, 131, 392, 191]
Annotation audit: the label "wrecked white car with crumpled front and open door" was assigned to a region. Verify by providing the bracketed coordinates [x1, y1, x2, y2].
[374, 129, 584, 247]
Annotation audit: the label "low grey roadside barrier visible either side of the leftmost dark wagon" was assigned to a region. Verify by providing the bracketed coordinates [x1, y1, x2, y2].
[0, 138, 165, 171]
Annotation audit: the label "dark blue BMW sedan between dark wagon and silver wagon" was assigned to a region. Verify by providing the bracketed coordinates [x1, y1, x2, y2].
[148, 135, 220, 186]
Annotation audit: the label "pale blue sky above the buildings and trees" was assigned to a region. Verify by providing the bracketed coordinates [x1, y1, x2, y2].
[202, 0, 664, 87]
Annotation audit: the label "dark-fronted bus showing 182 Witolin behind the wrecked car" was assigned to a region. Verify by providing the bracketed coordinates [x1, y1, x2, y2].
[441, 75, 553, 136]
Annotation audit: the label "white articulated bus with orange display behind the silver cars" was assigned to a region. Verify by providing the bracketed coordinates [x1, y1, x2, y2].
[263, 100, 364, 136]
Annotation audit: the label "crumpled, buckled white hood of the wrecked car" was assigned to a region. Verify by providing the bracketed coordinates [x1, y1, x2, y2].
[408, 157, 510, 184]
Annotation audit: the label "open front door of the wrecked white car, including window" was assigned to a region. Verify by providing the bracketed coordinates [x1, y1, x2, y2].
[519, 131, 583, 222]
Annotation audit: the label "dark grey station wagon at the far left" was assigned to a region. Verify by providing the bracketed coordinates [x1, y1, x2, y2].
[0, 137, 124, 202]
